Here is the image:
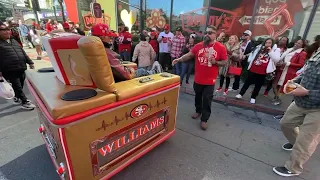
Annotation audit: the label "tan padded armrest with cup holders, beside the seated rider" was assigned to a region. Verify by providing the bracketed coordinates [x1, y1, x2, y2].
[115, 74, 180, 101]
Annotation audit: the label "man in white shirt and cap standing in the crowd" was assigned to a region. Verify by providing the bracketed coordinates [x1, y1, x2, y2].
[158, 25, 174, 71]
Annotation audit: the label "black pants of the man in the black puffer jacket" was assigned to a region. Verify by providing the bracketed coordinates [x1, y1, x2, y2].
[2, 71, 28, 104]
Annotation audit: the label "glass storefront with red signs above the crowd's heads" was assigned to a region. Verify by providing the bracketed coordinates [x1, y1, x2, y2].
[117, 0, 318, 40]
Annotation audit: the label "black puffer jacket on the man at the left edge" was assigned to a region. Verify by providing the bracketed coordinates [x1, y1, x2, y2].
[0, 39, 33, 73]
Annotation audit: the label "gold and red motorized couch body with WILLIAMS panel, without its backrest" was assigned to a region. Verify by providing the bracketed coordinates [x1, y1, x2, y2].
[26, 34, 180, 180]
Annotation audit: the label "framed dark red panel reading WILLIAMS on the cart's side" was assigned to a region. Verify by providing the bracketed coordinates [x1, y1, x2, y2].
[89, 108, 169, 176]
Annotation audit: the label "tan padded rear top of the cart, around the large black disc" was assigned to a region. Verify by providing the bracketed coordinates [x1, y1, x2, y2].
[26, 70, 116, 119]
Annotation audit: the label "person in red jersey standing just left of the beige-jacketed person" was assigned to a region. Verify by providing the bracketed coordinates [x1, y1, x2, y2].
[118, 27, 132, 61]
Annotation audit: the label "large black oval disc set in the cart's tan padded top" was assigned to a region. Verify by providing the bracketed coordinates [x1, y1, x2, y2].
[61, 89, 98, 101]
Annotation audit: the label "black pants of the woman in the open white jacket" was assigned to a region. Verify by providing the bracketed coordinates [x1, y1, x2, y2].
[240, 71, 266, 99]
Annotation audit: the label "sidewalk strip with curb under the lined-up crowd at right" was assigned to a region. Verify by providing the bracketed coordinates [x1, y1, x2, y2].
[180, 75, 293, 115]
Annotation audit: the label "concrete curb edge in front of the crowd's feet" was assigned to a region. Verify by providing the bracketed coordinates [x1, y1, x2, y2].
[180, 87, 284, 115]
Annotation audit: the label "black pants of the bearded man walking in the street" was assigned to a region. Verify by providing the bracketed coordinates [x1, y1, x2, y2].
[193, 83, 214, 122]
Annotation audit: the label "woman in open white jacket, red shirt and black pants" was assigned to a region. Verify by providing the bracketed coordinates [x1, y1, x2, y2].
[236, 38, 280, 104]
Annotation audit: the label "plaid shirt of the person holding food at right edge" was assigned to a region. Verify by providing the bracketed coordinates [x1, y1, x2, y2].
[294, 52, 320, 109]
